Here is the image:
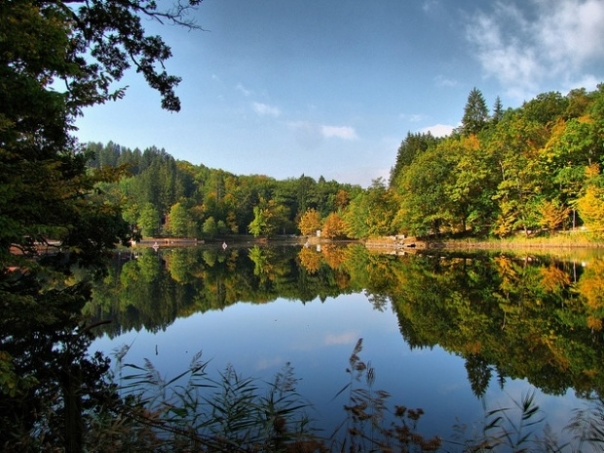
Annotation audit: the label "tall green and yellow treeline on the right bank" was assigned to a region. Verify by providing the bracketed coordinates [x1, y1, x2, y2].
[390, 85, 604, 237]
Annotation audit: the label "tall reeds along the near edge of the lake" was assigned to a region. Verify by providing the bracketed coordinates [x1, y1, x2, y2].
[82, 339, 604, 453]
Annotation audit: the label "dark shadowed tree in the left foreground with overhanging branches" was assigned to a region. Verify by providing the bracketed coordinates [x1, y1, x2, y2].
[0, 0, 199, 444]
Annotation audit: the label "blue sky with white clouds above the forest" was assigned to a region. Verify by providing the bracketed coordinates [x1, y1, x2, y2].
[77, 0, 604, 186]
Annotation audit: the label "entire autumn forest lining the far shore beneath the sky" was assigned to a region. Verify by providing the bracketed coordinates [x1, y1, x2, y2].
[86, 84, 604, 239]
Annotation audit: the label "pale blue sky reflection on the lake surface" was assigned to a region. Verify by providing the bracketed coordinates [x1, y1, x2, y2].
[92, 293, 581, 439]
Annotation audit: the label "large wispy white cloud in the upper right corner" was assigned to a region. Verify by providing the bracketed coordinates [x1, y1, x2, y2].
[466, 0, 604, 100]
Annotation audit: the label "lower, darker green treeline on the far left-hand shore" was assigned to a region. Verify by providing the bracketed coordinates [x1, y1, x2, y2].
[87, 142, 362, 238]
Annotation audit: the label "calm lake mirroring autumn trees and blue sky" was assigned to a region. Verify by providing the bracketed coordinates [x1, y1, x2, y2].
[85, 245, 604, 451]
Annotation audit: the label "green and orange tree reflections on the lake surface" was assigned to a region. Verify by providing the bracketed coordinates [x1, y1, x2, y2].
[85, 245, 604, 444]
